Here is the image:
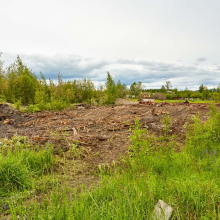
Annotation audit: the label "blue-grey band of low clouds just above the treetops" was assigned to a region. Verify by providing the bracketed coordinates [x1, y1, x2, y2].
[2, 53, 220, 90]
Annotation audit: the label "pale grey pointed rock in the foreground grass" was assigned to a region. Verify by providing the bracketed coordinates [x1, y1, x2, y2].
[151, 199, 173, 220]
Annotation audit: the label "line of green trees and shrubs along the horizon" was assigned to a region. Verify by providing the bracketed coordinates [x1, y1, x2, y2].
[0, 53, 220, 110]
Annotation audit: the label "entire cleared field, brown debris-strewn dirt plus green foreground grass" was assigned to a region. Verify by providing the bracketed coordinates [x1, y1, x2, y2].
[0, 100, 220, 219]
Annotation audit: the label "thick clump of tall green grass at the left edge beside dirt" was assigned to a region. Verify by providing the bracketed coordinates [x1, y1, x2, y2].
[0, 137, 55, 196]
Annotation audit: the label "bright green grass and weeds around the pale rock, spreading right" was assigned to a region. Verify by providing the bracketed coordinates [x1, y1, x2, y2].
[2, 107, 220, 220]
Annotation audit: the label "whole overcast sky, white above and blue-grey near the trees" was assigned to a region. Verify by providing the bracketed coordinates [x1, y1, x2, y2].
[0, 0, 220, 90]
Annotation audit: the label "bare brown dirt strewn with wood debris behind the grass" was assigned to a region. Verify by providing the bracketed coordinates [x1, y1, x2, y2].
[0, 101, 215, 171]
